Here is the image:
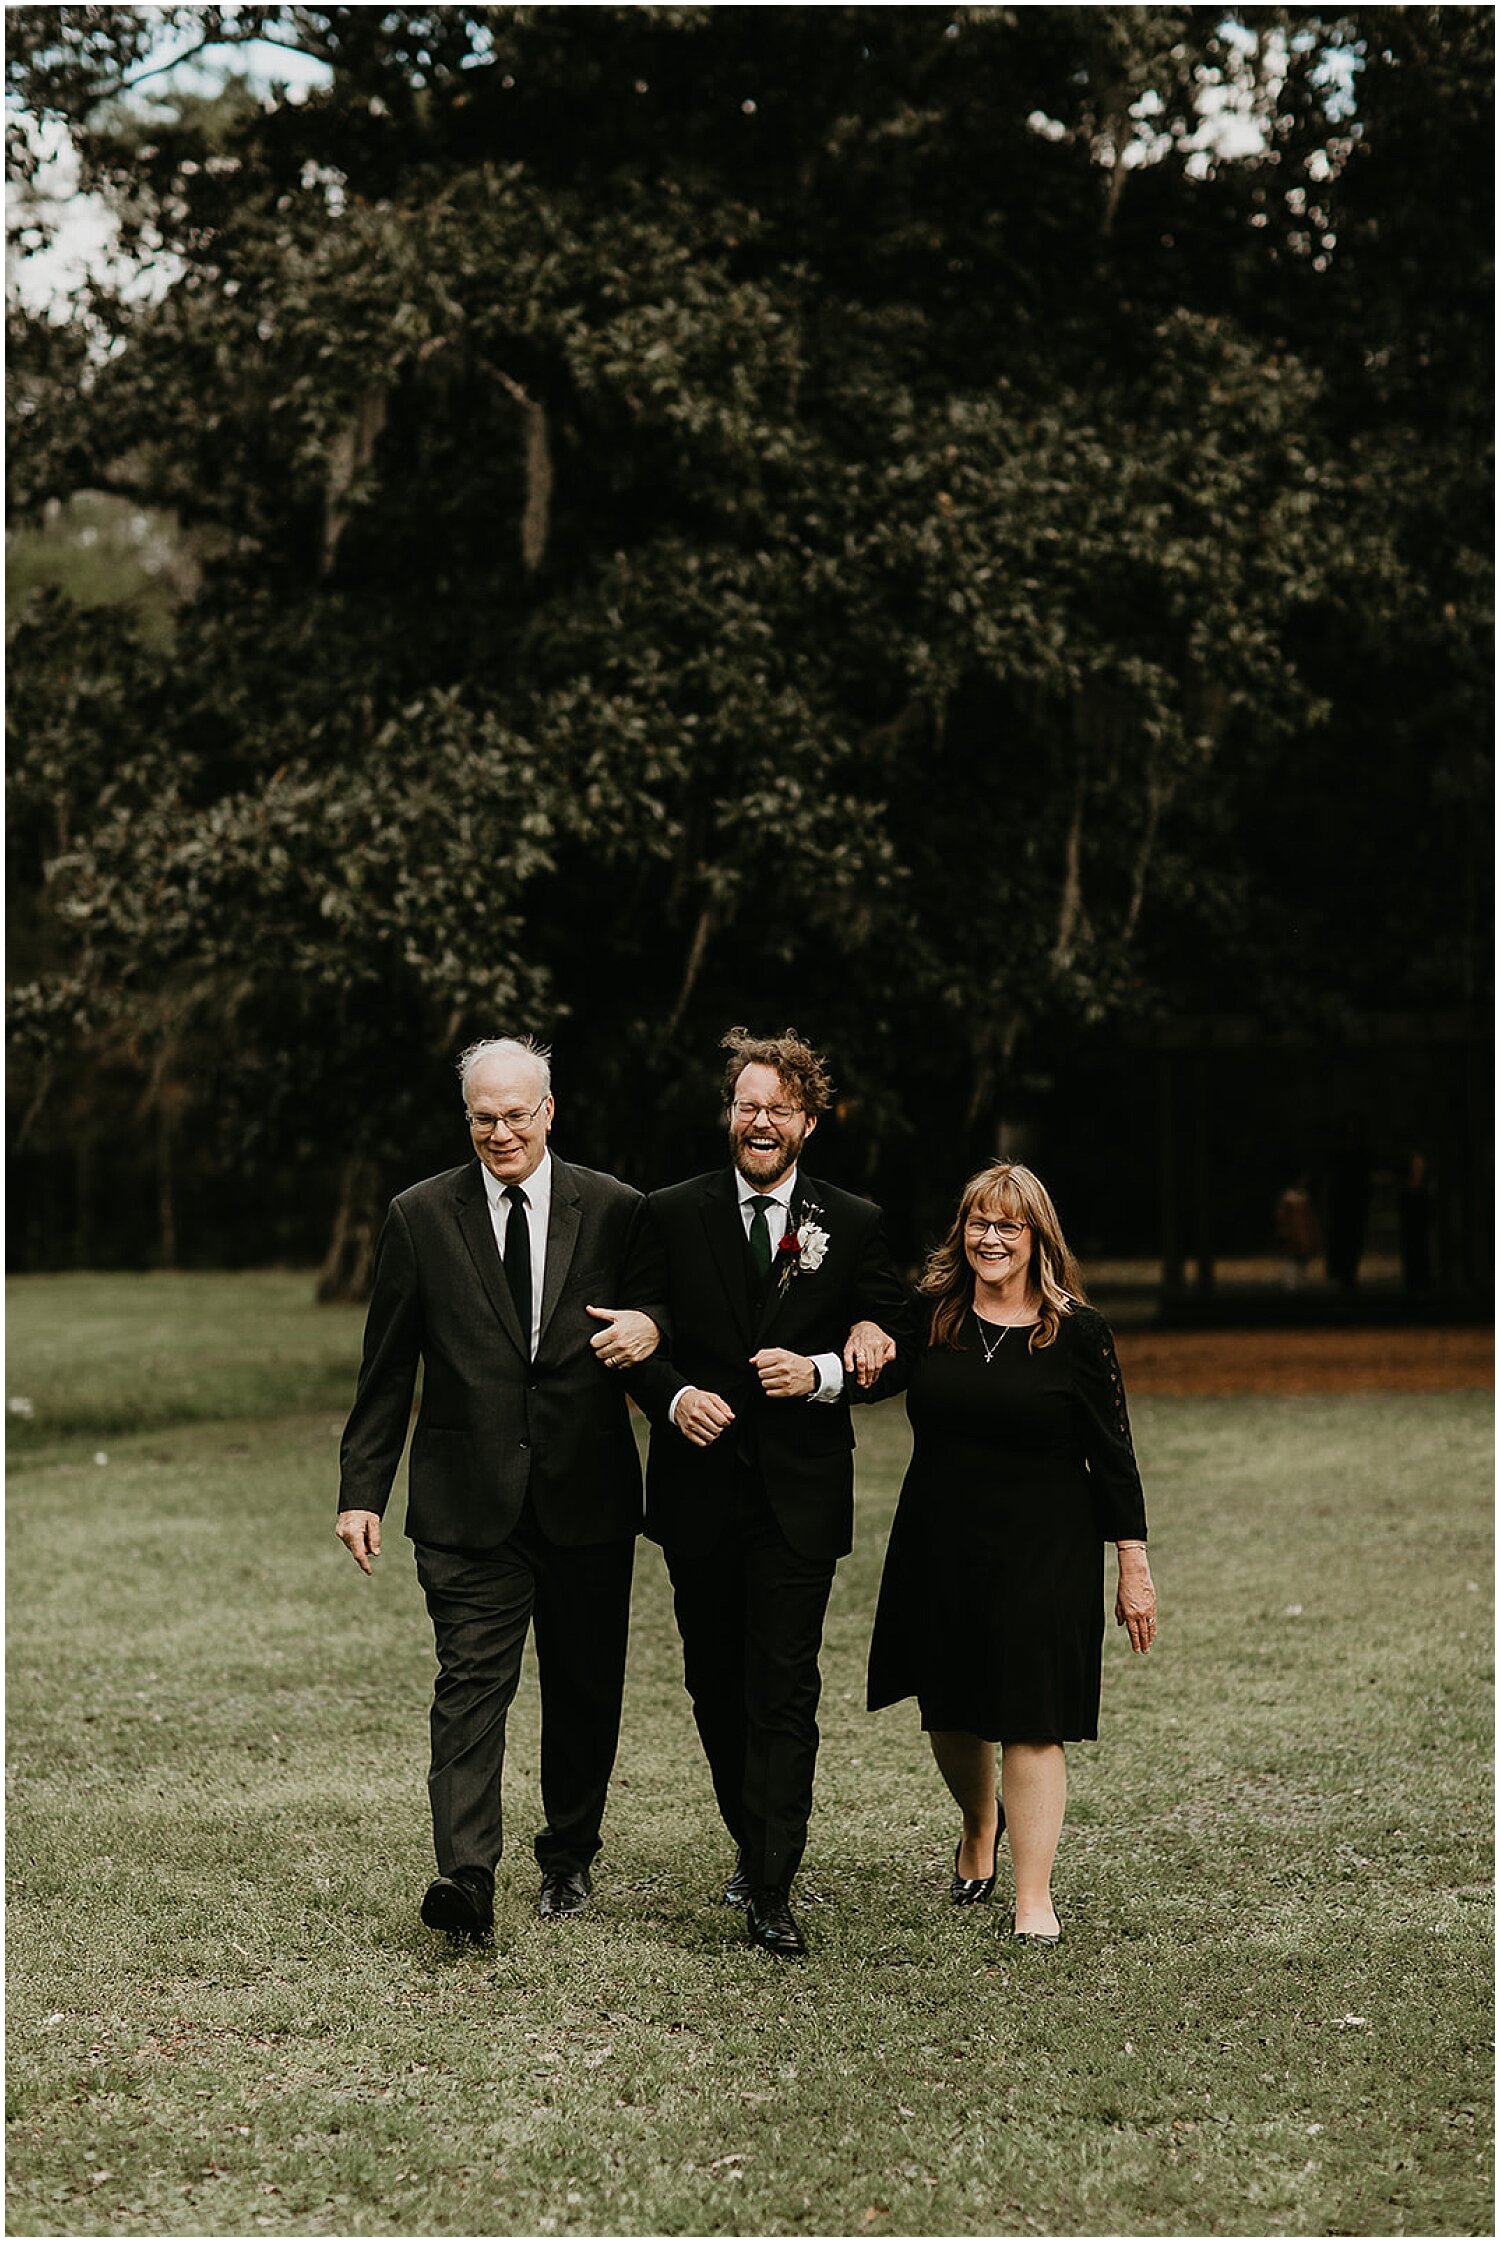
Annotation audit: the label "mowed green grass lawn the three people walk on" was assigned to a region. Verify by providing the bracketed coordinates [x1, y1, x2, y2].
[7, 1273, 1493, 2235]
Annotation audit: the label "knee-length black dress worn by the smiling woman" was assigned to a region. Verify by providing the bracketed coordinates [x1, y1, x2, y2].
[868, 1307, 1146, 1744]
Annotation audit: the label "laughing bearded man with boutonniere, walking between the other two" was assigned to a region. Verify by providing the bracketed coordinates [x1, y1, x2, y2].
[632, 1029, 910, 1955]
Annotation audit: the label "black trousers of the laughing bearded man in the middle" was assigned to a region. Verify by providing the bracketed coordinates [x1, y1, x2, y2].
[664, 1471, 836, 1886]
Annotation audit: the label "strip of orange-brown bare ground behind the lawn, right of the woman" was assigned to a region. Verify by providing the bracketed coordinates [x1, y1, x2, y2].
[1114, 1330, 1496, 1395]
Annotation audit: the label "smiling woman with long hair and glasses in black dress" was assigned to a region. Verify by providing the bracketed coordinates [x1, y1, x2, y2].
[870, 1161, 1157, 1946]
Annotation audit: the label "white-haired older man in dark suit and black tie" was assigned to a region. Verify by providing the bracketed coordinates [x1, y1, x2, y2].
[336, 1038, 664, 1937]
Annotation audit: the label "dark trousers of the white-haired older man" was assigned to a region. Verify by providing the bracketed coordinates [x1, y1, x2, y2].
[415, 1502, 635, 1881]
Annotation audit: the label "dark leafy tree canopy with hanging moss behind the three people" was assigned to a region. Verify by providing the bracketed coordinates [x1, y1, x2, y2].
[7, 7, 1493, 1282]
